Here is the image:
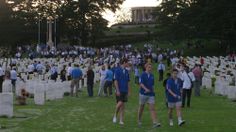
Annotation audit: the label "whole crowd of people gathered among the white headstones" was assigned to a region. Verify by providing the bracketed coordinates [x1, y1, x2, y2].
[0, 44, 208, 128]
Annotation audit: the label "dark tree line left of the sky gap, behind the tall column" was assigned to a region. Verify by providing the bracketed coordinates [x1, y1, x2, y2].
[0, 0, 124, 45]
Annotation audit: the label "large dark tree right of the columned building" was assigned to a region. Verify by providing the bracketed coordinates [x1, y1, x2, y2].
[155, 0, 236, 44]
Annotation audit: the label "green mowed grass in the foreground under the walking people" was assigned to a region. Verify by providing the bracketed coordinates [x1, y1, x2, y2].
[0, 63, 236, 132]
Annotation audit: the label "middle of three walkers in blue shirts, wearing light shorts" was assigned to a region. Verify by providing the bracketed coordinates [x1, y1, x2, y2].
[138, 64, 161, 128]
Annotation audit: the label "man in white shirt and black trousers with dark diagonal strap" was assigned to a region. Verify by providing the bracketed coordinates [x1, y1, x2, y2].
[181, 66, 195, 108]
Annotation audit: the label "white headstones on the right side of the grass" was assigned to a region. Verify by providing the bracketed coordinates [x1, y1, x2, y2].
[188, 56, 236, 101]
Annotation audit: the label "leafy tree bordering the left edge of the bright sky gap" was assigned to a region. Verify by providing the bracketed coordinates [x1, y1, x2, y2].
[62, 0, 124, 46]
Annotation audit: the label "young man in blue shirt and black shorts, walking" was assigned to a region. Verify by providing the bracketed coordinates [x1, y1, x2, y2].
[113, 58, 130, 125]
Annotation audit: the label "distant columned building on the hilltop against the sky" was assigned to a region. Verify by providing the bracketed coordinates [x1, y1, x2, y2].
[131, 7, 155, 23]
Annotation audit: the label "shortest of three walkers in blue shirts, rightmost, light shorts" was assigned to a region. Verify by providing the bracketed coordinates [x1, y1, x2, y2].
[166, 69, 185, 126]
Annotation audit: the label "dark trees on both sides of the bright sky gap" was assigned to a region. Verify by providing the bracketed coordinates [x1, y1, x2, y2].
[0, 0, 236, 46]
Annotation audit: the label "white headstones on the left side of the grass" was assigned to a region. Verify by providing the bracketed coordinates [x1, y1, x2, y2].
[0, 59, 101, 117]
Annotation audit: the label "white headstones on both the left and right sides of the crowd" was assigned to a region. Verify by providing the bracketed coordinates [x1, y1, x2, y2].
[0, 57, 236, 117]
